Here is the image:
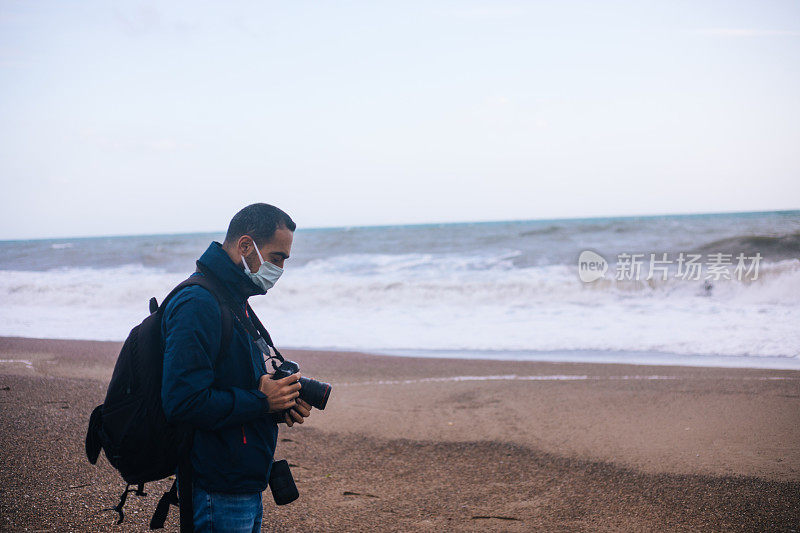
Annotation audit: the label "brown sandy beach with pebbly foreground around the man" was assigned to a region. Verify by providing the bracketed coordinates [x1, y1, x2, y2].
[0, 338, 800, 531]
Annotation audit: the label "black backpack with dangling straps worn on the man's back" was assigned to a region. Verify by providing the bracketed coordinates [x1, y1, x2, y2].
[86, 263, 233, 531]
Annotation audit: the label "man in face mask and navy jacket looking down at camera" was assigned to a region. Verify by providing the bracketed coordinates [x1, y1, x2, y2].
[161, 204, 311, 533]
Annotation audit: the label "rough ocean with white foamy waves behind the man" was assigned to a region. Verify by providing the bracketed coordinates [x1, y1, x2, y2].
[0, 211, 800, 369]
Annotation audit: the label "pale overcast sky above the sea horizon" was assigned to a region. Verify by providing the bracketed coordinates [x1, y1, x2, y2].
[0, 0, 800, 239]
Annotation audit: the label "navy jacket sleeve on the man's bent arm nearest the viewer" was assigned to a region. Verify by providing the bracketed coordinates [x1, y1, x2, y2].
[161, 286, 269, 431]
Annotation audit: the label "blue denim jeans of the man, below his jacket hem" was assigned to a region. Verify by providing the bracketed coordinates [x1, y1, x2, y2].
[192, 483, 264, 533]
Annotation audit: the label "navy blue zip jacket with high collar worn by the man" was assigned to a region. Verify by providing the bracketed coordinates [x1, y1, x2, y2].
[161, 242, 278, 493]
